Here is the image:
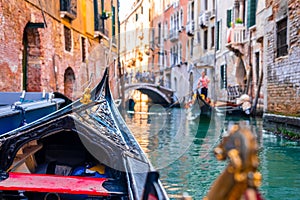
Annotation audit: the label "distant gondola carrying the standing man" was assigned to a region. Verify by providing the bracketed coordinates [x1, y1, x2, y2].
[185, 91, 212, 120]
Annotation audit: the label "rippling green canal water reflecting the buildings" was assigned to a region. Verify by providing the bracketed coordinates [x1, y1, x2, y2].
[125, 105, 300, 200]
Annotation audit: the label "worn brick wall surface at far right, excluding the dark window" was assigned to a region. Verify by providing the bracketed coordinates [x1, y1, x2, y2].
[266, 0, 300, 115]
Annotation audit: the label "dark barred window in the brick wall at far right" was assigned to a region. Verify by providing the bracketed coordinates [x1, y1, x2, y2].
[277, 18, 288, 57]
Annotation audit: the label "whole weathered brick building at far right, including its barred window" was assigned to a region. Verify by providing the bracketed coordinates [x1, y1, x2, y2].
[264, 0, 300, 116]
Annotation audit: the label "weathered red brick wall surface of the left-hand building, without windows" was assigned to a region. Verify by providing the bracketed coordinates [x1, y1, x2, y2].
[0, 0, 117, 98]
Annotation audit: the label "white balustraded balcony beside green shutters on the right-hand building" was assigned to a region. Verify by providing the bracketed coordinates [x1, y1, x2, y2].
[226, 24, 246, 54]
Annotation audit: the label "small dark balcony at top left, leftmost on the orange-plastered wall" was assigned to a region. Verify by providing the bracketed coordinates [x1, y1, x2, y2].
[60, 0, 77, 20]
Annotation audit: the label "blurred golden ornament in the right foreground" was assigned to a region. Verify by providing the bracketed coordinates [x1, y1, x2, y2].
[204, 125, 262, 200]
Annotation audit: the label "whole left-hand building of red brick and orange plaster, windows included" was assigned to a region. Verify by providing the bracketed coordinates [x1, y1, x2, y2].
[0, 0, 118, 99]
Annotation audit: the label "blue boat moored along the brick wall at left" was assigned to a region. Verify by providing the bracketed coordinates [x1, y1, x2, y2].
[0, 91, 70, 135]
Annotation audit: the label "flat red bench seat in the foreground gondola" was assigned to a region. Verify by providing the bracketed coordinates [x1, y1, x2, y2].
[0, 172, 123, 196]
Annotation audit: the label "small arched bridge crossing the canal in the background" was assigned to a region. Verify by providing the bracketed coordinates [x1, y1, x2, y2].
[124, 83, 174, 106]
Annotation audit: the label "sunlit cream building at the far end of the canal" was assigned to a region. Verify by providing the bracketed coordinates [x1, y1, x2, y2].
[120, 0, 151, 78]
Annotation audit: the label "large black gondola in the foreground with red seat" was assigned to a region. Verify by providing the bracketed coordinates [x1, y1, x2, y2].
[0, 69, 168, 200]
